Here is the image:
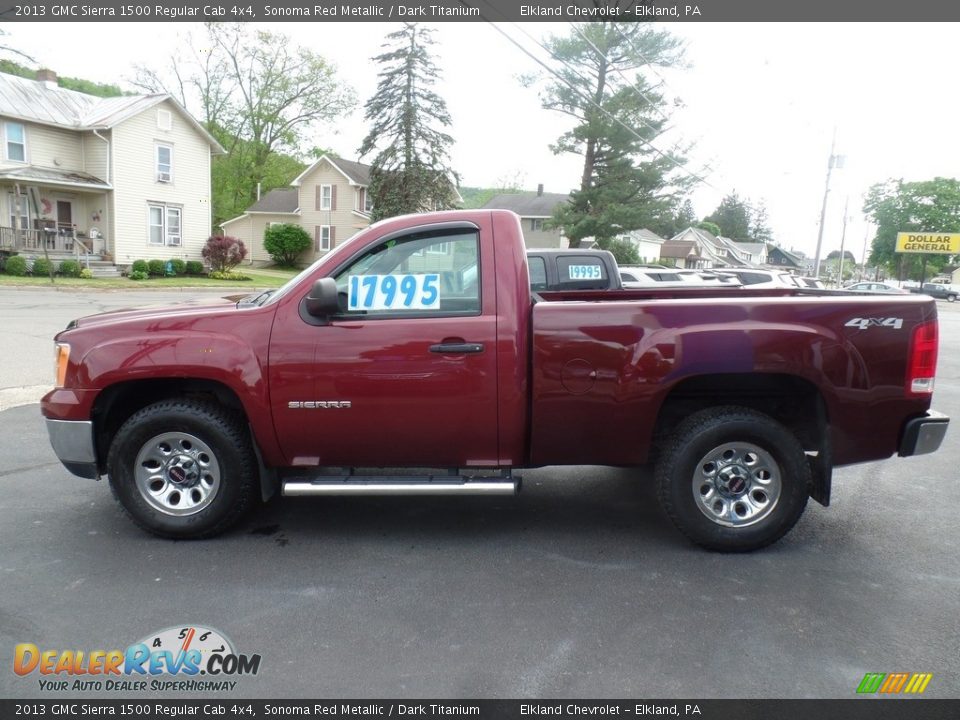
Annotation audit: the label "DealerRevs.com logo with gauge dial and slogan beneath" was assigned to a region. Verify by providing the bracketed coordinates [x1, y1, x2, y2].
[13, 625, 260, 692]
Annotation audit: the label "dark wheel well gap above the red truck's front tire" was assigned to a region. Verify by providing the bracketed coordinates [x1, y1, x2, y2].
[91, 378, 246, 472]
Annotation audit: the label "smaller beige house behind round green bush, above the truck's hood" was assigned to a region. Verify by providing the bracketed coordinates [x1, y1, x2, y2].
[221, 155, 372, 264]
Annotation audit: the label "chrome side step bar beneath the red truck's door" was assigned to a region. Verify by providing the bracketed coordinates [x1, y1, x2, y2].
[283, 475, 520, 497]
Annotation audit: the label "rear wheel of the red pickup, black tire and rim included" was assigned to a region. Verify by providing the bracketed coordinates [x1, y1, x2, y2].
[655, 406, 812, 552]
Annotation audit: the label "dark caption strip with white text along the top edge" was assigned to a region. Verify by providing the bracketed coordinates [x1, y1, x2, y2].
[0, 0, 960, 22]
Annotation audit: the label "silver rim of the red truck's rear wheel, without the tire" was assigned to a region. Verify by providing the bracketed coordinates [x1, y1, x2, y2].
[693, 442, 783, 528]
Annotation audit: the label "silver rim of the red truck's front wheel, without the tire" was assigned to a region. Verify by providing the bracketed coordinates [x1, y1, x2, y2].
[134, 432, 220, 517]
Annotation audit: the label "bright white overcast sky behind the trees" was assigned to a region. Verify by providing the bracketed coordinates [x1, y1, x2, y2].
[4, 22, 960, 260]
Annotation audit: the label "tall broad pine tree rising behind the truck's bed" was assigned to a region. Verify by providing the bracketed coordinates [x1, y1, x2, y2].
[543, 22, 686, 247]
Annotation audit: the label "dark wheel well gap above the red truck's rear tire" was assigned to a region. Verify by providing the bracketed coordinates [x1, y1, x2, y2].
[653, 373, 829, 453]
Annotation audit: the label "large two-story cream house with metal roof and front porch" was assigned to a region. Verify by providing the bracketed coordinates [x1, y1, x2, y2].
[0, 70, 224, 266]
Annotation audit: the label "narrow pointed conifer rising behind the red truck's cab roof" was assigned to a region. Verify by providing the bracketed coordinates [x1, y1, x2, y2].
[359, 23, 458, 221]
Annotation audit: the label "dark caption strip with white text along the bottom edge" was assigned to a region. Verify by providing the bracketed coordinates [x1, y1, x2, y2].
[0, 699, 960, 720]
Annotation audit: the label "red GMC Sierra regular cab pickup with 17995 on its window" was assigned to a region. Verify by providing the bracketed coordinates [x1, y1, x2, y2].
[42, 210, 949, 551]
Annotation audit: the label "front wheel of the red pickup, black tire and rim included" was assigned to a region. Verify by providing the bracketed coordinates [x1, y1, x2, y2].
[107, 400, 258, 539]
